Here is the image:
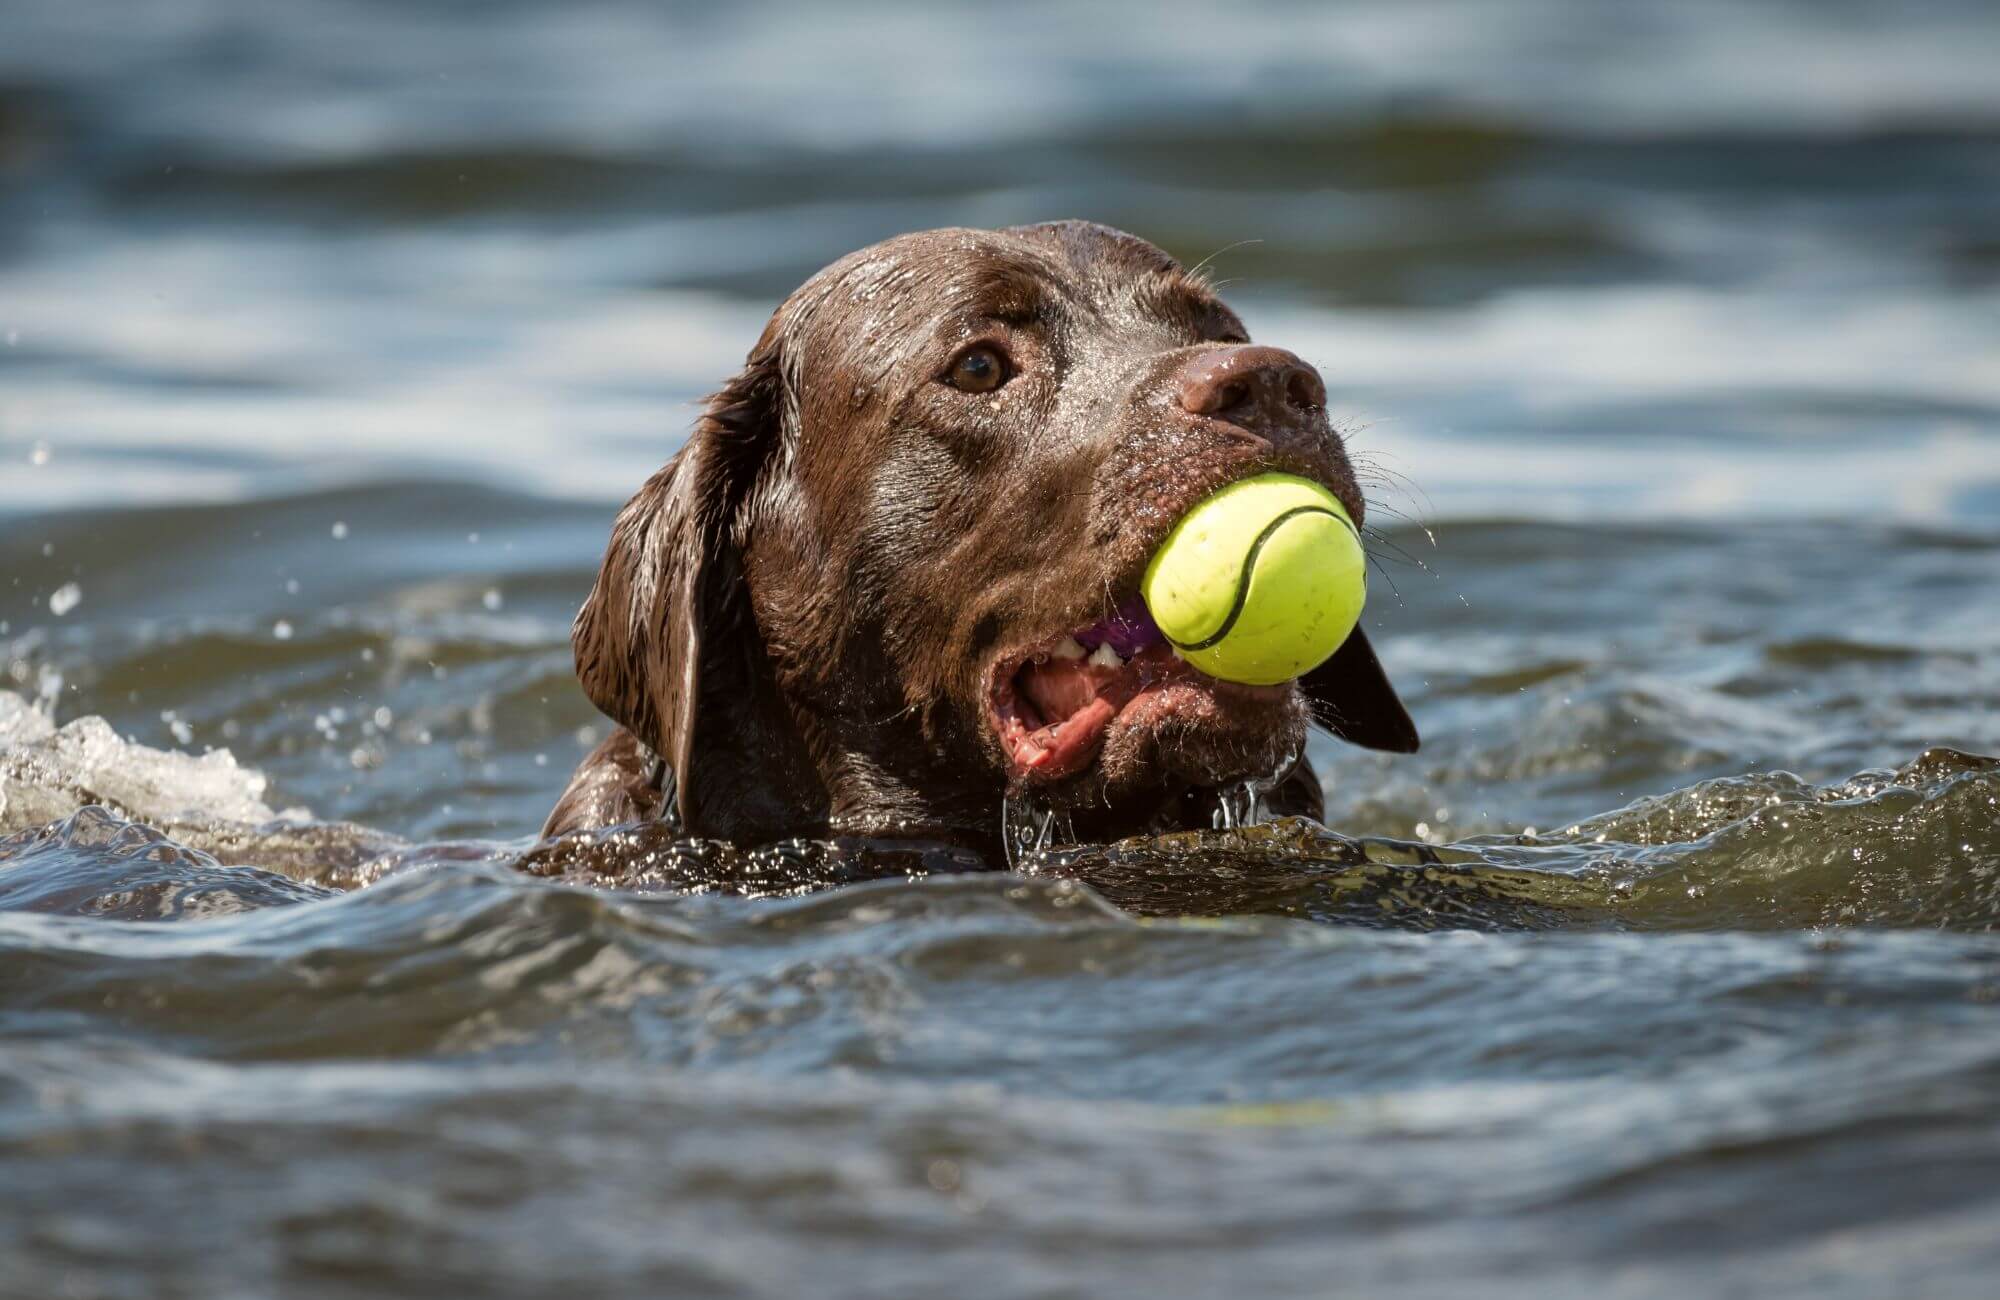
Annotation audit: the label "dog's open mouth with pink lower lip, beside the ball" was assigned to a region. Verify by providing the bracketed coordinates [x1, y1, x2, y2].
[990, 600, 1292, 782]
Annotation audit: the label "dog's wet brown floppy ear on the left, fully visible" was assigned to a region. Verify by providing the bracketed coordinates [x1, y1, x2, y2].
[570, 334, 782, 826]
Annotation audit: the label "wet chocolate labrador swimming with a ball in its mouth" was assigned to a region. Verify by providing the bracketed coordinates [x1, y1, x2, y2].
[544, 222, 1416, 850]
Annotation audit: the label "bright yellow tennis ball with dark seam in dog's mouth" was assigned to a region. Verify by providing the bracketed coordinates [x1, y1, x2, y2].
[1140, 474, 1368, 686]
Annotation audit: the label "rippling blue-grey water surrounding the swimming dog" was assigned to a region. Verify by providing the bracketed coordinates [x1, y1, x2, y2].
[0, 0, 2000, 1296]
